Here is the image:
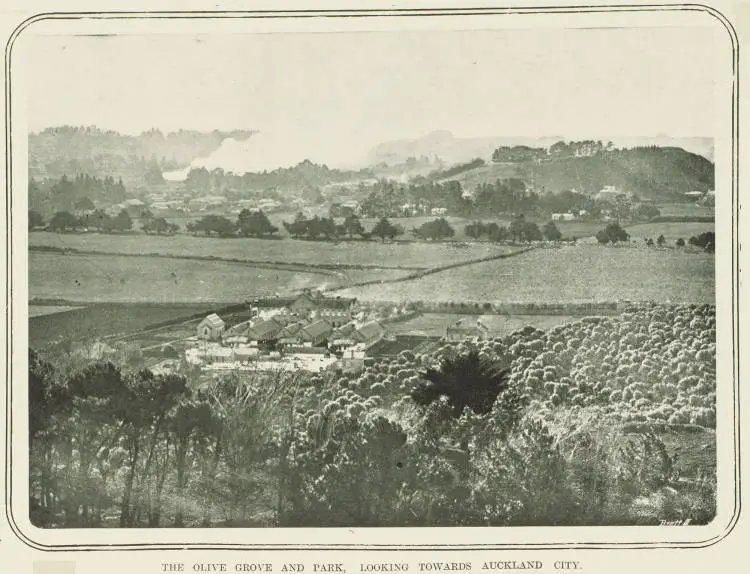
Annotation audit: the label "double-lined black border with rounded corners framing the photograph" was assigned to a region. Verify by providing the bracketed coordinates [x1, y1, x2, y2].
[4, 4, 741, 552]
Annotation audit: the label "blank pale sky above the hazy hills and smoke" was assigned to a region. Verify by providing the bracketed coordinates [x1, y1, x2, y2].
[23, 28, 716, 169]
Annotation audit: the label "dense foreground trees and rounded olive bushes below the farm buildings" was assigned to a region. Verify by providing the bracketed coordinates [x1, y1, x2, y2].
[30, 305, 716, 526]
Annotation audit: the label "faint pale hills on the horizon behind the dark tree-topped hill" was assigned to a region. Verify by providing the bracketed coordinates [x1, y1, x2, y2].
[368, 130, 714, 165]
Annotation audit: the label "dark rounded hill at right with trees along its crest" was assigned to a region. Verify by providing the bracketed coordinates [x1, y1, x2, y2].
[443, 147, 714, 200]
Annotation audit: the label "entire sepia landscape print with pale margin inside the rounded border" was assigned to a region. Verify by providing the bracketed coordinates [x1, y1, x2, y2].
[2, 3, 736, 552]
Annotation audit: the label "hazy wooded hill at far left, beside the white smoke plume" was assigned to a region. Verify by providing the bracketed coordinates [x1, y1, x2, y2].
[29, 126, 255, 189]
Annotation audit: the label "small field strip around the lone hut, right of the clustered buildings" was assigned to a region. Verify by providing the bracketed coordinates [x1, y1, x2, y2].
[386, 313, 578, 337]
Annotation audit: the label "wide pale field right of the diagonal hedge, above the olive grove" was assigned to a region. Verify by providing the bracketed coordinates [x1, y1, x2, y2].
[340, 245, 715, 303]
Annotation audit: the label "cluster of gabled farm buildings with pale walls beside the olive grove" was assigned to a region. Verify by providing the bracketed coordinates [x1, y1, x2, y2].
[185, 292, 385, 371]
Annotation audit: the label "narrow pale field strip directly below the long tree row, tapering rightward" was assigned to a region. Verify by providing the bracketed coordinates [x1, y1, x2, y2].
[29, 232, 514, 269]
